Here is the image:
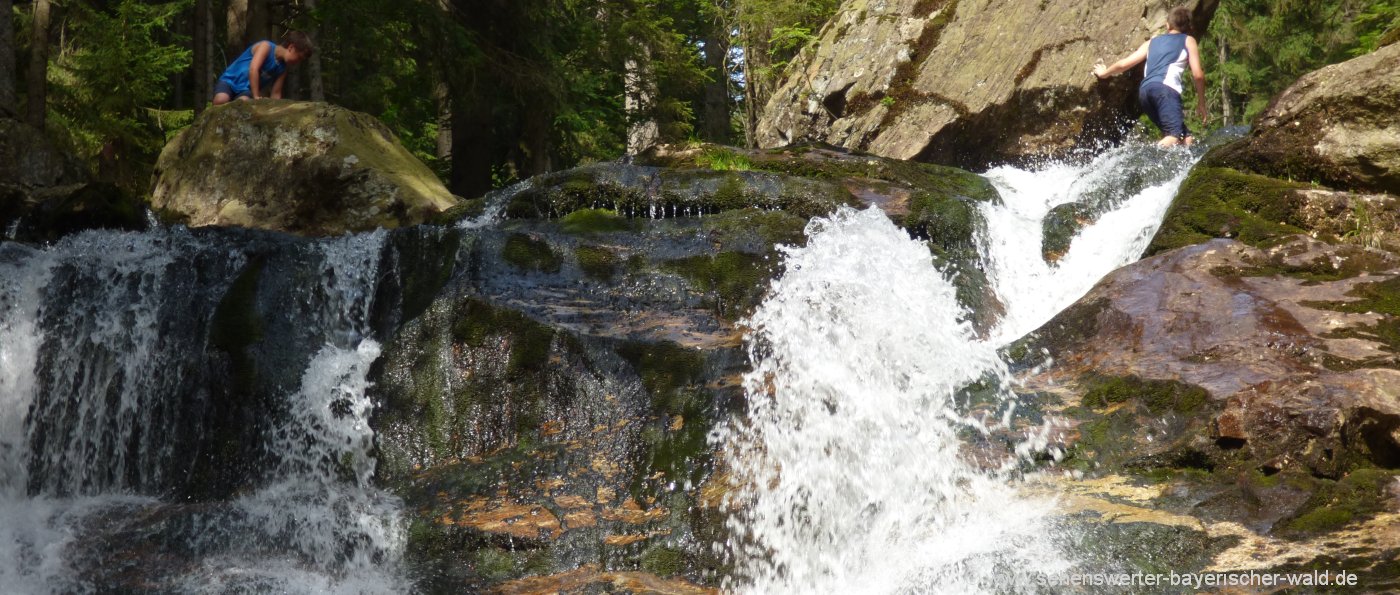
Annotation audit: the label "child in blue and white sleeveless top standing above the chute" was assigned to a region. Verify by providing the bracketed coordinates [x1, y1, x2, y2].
[1093, 7, 1210, 147]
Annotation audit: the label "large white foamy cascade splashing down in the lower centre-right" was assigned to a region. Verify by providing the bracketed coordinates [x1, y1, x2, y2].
[715, 209, 1063, 594]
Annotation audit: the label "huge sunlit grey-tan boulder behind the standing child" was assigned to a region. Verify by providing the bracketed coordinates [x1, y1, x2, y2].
[759, 0, 1218, 168]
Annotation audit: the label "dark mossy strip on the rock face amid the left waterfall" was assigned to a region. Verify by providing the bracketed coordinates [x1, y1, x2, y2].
[209, 258, 265, 393]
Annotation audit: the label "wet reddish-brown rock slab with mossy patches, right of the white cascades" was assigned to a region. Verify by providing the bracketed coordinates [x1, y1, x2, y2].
[1011, 235, 1400, 535]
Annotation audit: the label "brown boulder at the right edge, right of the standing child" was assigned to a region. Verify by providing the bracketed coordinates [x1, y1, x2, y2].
[1211, 45, 1400, 195]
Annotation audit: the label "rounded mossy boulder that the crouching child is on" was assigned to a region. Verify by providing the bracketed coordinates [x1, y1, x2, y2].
[151, 99, 456, 235]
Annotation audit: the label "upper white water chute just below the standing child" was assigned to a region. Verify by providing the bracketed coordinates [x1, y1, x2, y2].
[981, 146, 1196, 344]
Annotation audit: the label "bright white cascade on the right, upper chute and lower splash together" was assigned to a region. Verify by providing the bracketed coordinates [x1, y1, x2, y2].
[711, 141, 1193, 594]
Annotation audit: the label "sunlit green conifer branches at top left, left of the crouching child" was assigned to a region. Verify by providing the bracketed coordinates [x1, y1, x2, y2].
[49, 0, 192, 190]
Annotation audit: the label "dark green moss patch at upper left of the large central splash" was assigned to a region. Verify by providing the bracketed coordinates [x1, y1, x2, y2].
[662, 252, 777, 319]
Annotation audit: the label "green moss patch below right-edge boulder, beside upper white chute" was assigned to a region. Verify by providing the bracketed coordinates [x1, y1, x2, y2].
[1147, 167, 1308, 255]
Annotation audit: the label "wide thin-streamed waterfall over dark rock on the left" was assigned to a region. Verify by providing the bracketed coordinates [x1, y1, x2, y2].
[0, 228, 403, 592]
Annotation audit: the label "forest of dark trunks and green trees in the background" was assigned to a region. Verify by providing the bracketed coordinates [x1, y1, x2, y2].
[0, 0, 1400, 197]
